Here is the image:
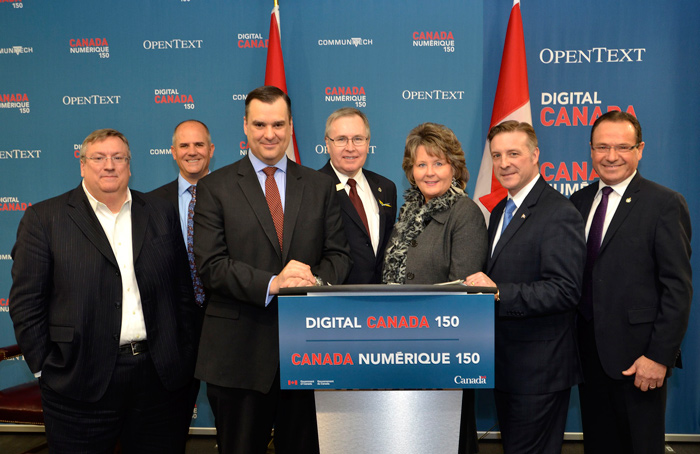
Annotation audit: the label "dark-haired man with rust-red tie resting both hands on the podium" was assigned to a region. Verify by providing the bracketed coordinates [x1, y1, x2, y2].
[194, 86, 351, 454]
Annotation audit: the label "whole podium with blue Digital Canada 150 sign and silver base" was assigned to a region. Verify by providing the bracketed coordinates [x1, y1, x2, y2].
[278, 284, 496, 454]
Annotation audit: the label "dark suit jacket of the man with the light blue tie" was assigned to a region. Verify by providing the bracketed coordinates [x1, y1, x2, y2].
[486, 177, 586, 394]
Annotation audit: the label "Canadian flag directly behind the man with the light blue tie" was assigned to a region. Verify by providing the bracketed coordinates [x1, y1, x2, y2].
[474, 0, 532, 225]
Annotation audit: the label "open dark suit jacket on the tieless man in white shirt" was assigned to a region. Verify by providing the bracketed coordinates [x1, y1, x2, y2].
[10, 186, 196, 402]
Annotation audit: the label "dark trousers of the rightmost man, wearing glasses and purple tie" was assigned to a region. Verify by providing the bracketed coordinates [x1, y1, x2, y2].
[578, 318, 666, 454]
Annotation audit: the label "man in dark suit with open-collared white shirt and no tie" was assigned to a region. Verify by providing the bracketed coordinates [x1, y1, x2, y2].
[10, 129, 196, 453]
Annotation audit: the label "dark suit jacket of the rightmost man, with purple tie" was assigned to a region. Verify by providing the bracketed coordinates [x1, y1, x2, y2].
[571, 172, 693, 379]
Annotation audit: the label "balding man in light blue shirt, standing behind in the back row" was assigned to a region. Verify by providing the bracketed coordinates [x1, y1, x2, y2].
[151, 120, 214, 444]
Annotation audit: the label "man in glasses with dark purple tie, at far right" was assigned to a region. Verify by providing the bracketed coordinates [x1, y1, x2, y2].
[571, 112, 693, 454]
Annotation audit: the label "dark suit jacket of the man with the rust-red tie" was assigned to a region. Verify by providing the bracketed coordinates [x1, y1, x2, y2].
[194, 157, 351, 392]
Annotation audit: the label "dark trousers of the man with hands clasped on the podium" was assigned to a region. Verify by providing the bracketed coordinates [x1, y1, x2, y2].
[207, 371, 319, 454]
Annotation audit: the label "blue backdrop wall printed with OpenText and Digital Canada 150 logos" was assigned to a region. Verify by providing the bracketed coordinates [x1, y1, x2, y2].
[0, 0, 700, 434]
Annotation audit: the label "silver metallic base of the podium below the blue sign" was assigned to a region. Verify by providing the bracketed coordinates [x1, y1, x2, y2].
[314, 390, 462, 454]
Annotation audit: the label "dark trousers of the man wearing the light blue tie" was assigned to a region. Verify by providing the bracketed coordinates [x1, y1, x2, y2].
[494, 388, 571, 454]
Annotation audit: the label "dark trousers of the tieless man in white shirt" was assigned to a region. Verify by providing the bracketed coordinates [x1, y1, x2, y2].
[40, 352, 189, 454]
